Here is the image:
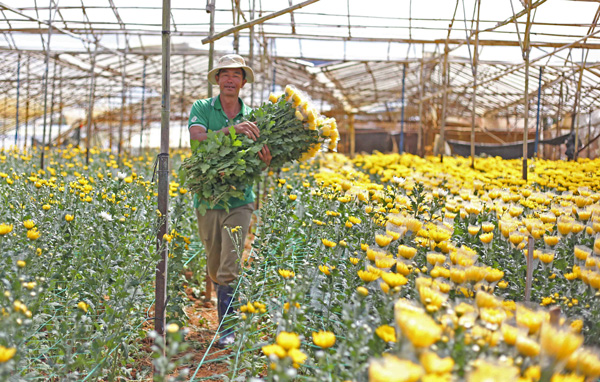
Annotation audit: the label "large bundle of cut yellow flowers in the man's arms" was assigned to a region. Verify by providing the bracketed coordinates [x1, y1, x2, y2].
[181, 86, 339, 213]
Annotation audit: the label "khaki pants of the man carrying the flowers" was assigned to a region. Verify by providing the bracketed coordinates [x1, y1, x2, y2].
[196, 203, 254, 285]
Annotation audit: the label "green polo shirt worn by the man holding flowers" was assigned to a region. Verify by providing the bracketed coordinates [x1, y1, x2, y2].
[188, 96, 254, 210]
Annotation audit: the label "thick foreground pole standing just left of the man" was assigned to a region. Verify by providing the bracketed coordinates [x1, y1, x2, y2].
[154, 0, 171, 346]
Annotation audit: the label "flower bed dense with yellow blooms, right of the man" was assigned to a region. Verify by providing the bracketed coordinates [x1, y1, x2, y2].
[225, 154, 600, 382]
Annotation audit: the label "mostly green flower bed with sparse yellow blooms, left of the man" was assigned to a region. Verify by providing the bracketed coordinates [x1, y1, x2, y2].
[0, 148, 195, 380]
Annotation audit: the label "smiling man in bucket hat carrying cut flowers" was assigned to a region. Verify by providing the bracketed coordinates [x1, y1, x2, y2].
[188, 54, 271, 347]
